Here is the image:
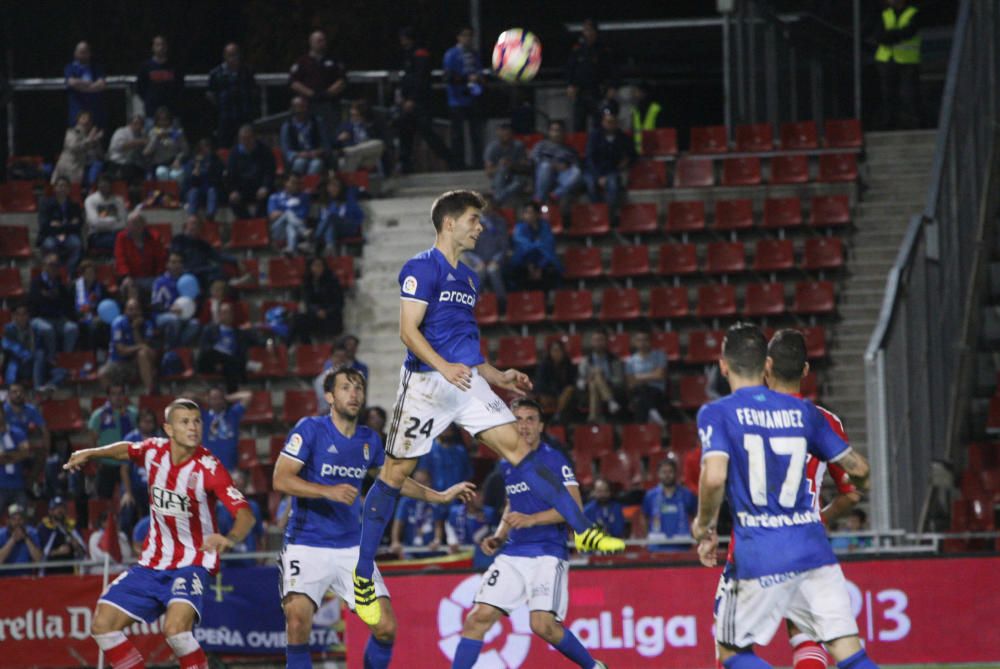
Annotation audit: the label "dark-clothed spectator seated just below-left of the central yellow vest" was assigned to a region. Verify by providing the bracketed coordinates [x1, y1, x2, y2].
[584, 111, 635, 217]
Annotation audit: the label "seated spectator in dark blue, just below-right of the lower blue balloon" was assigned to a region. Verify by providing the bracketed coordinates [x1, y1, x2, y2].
[101, 297, 158, 396]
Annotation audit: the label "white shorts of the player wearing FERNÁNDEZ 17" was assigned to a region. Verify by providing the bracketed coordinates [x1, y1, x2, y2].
[715, 564, 858, 648]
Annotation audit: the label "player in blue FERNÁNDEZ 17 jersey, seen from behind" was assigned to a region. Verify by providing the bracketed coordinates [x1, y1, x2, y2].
[691, 323, 876, 669]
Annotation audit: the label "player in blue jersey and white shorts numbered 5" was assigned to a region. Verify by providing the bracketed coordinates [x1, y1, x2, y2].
[274, 368, 473, 669]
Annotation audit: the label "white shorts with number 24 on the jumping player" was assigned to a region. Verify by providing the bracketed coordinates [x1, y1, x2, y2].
[385, 366, 514, 458]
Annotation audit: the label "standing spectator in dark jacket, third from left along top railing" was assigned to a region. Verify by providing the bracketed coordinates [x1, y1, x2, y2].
[207, 43, 257, 149]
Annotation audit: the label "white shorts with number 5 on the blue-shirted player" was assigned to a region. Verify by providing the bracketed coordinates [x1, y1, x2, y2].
[278, 544, 389, 611]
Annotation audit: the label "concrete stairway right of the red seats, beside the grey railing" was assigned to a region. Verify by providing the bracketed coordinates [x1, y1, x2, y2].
[822, 130, 935, 451]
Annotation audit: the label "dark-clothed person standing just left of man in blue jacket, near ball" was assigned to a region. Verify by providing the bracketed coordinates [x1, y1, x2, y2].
[397, 27, 459, 174]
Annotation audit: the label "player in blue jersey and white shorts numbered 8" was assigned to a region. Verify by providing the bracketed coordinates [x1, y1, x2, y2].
[451, 399, 604, 669]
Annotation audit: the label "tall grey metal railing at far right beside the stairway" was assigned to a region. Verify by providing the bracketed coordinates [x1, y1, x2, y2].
[865, 0, 1000, 530]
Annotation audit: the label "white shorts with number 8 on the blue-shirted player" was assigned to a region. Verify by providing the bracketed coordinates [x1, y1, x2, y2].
[474, 555, 569, 622]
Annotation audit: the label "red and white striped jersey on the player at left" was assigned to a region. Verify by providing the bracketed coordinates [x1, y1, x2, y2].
[128, 438, 249, 572]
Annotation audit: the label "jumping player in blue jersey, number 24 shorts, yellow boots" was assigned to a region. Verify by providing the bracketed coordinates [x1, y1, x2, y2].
[354, 190, 625, 625]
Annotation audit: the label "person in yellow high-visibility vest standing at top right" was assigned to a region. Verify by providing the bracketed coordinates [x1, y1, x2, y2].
[875, 0, 920, 129]
